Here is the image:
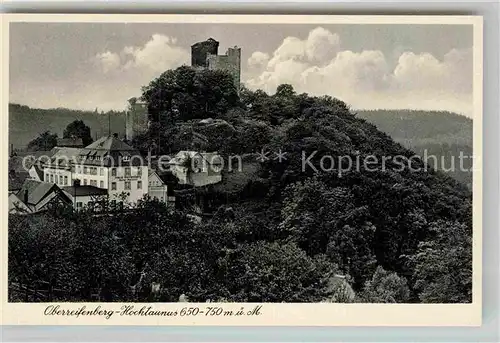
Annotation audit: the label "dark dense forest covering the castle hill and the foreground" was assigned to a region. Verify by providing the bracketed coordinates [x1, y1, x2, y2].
[9, 66, 472, 303]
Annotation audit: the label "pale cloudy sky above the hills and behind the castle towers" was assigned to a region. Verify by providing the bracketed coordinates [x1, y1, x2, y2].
[10, 23, 473, 116]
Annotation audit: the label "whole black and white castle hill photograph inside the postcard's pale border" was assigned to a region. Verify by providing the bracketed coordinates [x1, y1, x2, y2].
[4, 15, 482, 316]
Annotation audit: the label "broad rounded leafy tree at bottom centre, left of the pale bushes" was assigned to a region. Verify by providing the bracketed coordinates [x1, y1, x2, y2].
[219, 241, 336, 302]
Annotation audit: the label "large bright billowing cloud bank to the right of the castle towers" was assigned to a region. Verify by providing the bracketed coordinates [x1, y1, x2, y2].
[244, 28, 472, 115]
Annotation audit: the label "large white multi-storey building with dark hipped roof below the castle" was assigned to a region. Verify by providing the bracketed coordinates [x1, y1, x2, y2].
[43, 136, 148, 203]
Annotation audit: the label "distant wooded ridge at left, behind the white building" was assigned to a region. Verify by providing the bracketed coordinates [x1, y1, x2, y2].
[9, 104, 125, 149]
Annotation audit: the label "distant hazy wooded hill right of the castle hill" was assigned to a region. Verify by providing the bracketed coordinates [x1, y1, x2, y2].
[357, 110, 472, 188]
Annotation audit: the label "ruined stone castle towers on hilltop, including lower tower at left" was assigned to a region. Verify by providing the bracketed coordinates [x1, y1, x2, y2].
[125, 38, 241, 141]
